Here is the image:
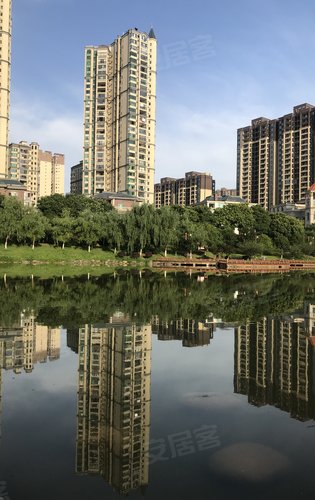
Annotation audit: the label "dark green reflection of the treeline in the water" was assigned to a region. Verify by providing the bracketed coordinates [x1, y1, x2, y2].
[0, 271, 315, 328]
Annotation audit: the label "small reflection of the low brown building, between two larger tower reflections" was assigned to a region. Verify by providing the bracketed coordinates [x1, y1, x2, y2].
[152, 316, 214, 347]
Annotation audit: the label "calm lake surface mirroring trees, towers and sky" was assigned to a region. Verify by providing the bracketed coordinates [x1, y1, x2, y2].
[0, 273, 315, 500]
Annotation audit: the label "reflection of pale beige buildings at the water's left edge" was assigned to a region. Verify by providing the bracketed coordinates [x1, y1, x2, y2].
[0, 314, 61, 373]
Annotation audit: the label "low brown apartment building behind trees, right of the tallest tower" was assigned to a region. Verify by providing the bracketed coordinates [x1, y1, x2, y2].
[154, 172, 215, 208]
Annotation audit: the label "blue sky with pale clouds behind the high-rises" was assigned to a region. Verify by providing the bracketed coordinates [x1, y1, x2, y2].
[9, 0, 315, 192]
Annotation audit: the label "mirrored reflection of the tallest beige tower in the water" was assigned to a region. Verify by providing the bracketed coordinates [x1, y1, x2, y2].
[76, 313, 151, 493]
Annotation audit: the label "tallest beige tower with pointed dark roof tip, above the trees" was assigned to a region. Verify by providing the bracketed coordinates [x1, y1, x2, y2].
[82, 28, 157, 203]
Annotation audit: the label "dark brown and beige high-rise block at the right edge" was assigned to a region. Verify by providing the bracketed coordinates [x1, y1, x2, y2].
[236, 103, 315, 209]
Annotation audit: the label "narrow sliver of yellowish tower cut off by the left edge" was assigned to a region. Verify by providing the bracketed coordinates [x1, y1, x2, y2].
[0, 0, 12, 178]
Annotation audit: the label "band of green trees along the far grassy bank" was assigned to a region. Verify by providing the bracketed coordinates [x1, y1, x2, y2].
[0, 195, 315, 258]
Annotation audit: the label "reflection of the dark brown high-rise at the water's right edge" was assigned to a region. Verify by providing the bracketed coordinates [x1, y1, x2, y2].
[234, 304, 315, 420]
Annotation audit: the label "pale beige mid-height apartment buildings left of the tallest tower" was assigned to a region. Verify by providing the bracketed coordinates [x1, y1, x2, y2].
[7, 141, 65, 206]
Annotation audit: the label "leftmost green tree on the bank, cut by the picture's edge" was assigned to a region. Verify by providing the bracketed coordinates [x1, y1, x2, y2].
[0, 196, 24, 250]
